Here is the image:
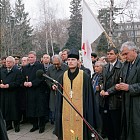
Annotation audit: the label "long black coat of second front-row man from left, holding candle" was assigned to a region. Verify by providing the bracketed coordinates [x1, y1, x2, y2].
[22, 62, 46, 117]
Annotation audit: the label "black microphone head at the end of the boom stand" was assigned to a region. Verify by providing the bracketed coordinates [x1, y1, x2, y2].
[36, 70, 58, 84]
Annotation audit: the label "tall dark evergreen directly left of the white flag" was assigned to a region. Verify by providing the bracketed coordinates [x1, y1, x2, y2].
[65, 0, 82, 49]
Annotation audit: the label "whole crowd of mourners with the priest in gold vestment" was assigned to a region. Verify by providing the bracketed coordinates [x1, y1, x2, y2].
[0, 41, 140, 140]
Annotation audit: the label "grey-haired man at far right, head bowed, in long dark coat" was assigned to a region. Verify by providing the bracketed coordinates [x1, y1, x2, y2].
[116, 41, 140, 140]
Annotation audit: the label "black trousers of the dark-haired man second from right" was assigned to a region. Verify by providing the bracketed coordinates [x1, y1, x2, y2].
[101, 109, 121, 140]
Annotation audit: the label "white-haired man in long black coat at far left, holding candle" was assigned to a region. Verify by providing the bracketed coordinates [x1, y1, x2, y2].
[0, 56, 22, 132]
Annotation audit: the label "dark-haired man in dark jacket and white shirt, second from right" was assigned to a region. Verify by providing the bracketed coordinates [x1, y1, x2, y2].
[100, 47, 122, 140]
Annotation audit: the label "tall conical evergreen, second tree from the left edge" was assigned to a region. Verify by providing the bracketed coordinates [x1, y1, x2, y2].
[13, 0, 33, 55]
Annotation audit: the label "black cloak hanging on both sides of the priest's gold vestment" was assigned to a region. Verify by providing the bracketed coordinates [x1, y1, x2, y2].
[55, 70, 95, 140]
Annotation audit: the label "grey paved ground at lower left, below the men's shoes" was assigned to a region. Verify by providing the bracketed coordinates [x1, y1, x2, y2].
[7, 123, 58, 140]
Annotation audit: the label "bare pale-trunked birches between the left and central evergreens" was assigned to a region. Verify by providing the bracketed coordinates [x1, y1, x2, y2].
[34, 0, 69, 55]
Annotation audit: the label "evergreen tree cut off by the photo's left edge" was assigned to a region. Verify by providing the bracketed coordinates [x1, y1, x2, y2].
[0, 0, 12, 56]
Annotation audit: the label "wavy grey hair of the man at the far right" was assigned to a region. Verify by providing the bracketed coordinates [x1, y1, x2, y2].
[120, 41, 138, 51]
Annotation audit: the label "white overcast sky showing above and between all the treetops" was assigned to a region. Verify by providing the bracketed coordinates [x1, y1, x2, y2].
[10, 0, 140, 24]
